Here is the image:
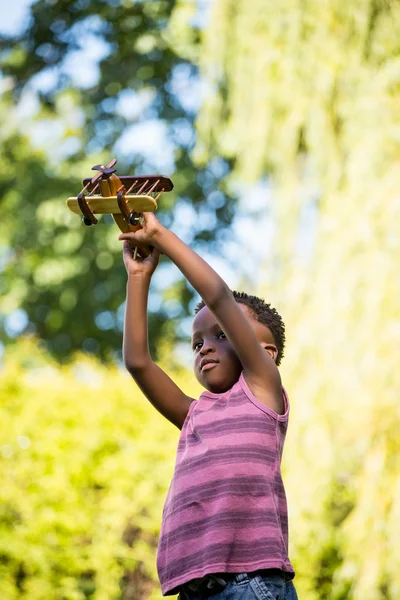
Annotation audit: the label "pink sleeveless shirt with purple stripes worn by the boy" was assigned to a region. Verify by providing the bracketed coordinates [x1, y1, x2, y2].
[157, 373, 294, 596]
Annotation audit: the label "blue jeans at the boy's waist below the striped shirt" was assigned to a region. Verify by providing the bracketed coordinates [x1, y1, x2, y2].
[178, 572, 298, 600]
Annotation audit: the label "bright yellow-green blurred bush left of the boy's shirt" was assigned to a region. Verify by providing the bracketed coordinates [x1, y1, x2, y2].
[0, 342, 188, 600]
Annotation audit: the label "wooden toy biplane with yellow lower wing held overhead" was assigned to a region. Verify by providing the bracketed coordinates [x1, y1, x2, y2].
[67, 158, 174, 257]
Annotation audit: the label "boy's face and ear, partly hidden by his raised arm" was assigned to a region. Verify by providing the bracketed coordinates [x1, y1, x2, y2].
[192, 303, 272, 393]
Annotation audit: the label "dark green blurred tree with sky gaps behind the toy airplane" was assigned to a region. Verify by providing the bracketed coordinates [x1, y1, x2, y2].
[0, 0, 233, 360]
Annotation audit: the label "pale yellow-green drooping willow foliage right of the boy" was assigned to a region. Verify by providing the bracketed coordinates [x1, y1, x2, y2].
[196, 0, 400, 600]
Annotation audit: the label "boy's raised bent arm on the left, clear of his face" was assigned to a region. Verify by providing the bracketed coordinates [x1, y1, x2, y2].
[123, 242, 193, 429]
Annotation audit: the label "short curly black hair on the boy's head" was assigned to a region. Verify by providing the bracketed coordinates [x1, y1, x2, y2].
[194, 290, 286, 365]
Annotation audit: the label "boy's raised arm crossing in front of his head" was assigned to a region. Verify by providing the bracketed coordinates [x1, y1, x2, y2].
[120, 213, 283, 413]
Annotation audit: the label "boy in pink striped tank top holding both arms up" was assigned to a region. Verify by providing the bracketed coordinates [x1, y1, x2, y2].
[119, 213, 297, 600]
